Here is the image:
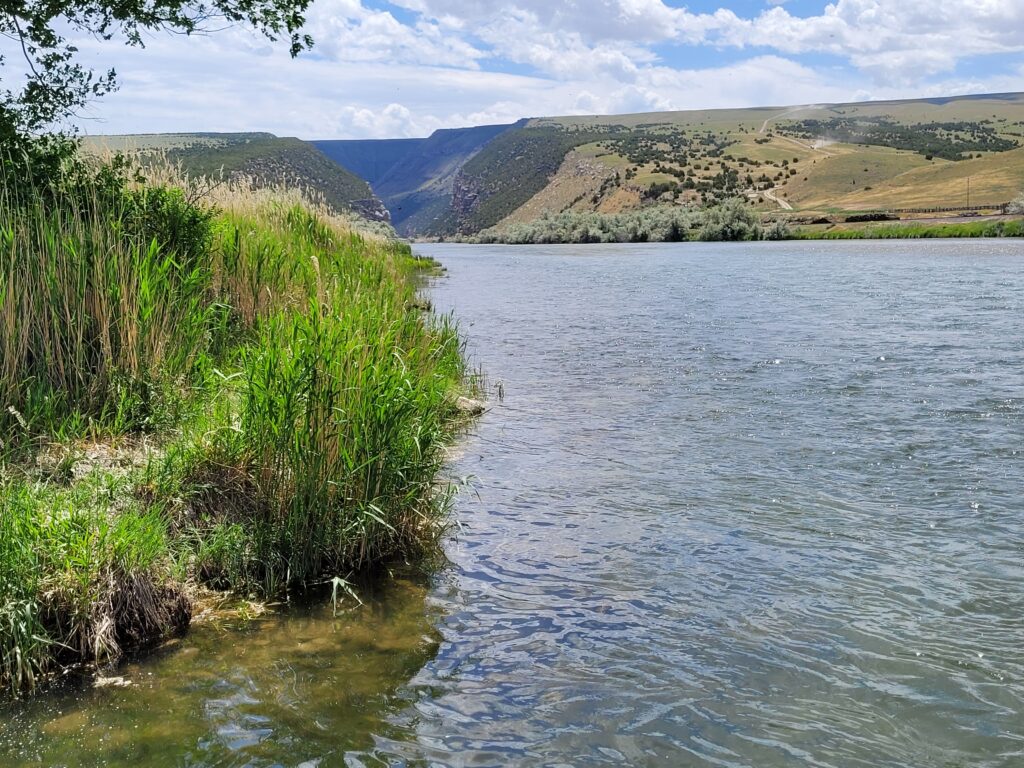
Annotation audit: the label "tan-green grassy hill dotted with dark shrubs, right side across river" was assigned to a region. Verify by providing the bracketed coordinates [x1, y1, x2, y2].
[528, 93, 1024, 221]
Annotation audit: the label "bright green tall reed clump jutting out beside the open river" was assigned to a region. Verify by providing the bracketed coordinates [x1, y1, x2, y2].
[165, 195, 465, 593]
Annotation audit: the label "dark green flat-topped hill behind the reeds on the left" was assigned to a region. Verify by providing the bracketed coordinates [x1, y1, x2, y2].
[85, 133, 388, 221]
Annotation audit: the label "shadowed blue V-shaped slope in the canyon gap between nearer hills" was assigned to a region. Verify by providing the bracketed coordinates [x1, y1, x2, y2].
[313, 125, 513, 236]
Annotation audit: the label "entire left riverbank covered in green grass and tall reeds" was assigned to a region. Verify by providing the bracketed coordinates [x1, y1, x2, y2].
[0, 157, 467, 693]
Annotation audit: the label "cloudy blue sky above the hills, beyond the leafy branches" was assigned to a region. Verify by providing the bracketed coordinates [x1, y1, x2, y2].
[28, 0, 1024, 139]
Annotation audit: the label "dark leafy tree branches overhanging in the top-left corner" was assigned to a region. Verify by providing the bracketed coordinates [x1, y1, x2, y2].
[0, 0, 312, 139]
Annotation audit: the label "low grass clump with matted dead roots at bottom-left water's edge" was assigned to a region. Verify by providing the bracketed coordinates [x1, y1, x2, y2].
[0, 473, 190, 691]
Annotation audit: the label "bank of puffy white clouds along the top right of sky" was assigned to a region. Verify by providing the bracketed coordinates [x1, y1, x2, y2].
[395, 0, 1024, 81]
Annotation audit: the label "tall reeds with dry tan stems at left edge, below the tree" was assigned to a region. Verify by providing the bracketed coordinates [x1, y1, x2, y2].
[0, 167, 211, 449]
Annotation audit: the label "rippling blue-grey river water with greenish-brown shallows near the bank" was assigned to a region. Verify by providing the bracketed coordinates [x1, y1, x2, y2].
[0, 241, 1024, 768]
